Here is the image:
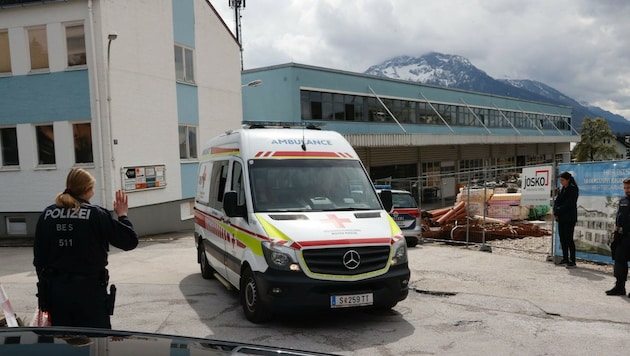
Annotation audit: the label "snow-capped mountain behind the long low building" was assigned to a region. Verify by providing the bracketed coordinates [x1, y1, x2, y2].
[364, 52, 630, 134]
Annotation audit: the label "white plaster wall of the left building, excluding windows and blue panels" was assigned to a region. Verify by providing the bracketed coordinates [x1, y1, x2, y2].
[0, 0, 242, 217]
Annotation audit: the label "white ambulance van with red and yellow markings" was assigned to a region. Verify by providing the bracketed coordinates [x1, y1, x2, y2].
[195, 122, 410, 323]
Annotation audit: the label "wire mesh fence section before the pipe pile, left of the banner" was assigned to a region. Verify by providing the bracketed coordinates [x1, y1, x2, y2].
[375, 166, 557, 259]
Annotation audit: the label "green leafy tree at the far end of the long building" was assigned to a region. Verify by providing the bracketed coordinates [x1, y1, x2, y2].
[573, 117, 621, 162]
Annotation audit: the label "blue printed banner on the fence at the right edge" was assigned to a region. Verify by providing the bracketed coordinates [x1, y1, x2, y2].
[554, 161, 630, 263]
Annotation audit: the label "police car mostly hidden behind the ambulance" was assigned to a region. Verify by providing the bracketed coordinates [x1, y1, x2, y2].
[375, 185, 422, 247]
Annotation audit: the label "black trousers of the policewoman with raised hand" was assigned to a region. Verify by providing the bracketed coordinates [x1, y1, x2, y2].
[49, 275, 112, 329]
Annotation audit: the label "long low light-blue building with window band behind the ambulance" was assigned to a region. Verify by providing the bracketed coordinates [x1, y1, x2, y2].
[242, 63, 580, 203]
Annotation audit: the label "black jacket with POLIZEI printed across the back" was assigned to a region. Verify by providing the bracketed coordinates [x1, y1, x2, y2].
[33, 198, 138, 274]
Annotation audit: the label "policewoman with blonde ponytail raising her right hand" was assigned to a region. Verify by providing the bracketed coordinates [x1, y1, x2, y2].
[33, 168, 138, 329]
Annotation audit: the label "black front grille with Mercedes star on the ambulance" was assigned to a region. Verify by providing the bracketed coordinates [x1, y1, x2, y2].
[302, 246, 390, 276]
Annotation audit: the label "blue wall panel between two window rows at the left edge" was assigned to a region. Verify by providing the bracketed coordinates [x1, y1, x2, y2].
[0, 70, 92, 125]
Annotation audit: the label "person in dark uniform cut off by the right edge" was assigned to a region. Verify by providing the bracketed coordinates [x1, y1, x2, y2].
[606, 178, 630, 297]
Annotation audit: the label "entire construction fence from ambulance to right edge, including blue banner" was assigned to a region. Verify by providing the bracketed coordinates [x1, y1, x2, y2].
[377, 160, 630, 264]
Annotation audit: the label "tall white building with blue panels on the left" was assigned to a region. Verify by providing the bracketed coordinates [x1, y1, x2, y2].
[0, 0, 242, 239]
